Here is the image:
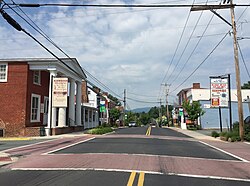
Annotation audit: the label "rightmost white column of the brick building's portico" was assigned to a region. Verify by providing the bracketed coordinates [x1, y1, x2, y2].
[76, 81, 82, 126]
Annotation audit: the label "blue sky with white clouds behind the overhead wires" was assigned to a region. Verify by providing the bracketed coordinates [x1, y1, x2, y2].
[0, 0, 250, 109]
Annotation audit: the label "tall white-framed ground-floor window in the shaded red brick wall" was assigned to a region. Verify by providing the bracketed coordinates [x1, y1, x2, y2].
[30, 94, 41, 122]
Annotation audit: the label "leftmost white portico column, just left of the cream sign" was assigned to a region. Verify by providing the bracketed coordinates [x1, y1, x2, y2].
[46, 69, 57, 136]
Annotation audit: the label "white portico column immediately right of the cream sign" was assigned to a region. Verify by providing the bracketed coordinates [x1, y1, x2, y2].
[69, 79, 75, 126]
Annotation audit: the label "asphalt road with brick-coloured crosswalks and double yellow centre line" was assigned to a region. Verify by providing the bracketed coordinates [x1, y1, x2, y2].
[0, 127, 250, 186]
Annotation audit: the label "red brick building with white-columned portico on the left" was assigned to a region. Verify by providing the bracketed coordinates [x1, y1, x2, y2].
[0, 58, 86, 137]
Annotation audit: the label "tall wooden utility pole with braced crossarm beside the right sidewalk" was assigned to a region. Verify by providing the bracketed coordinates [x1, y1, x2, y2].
[191, 0, 244, 141]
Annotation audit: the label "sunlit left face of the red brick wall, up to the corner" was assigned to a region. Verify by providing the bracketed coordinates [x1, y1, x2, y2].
[0, 62, 29, 136]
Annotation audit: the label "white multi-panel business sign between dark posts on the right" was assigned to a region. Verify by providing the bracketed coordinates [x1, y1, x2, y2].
[210, 78, 228, 107]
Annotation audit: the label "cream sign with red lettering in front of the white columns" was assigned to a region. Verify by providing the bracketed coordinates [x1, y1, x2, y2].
[52, 78, 68, 107]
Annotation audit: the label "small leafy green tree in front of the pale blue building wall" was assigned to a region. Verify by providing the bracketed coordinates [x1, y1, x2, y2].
[182, 100, 205, 122]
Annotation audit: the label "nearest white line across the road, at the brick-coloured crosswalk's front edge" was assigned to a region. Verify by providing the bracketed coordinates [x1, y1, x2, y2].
[11, 168, 250, 182]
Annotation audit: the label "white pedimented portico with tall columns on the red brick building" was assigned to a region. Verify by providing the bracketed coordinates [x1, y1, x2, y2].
[29, 58, 86, 135]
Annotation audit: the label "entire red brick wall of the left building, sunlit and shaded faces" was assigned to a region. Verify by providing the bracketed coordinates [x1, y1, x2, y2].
[0, 62, 49, 136]
